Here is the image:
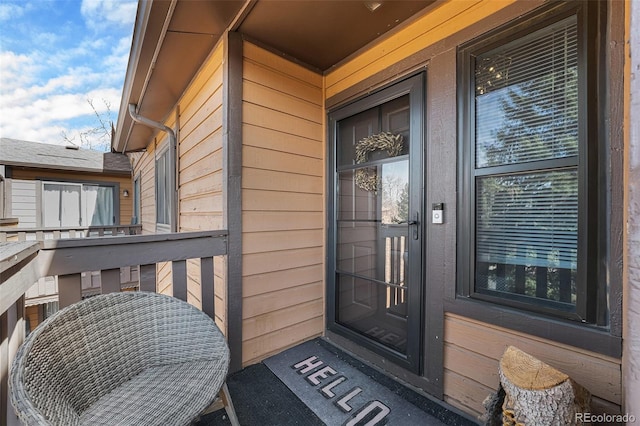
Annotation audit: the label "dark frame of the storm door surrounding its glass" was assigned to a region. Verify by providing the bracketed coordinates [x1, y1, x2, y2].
[326, 71, 427, 374]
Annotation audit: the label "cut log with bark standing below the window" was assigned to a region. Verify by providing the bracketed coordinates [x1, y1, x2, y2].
[499, 346, 591, 426]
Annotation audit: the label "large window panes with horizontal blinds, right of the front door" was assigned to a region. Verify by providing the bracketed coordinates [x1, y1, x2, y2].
[474, 16, 579, 310]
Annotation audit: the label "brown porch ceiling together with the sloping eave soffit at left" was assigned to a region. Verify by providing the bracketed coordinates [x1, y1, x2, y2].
[112, 0, 436, 152]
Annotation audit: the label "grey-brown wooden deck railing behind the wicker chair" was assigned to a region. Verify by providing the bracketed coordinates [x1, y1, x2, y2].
[0, 231, 227, 425]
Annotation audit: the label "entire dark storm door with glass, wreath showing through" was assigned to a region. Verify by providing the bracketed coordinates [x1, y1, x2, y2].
[327, 74, 424, 372]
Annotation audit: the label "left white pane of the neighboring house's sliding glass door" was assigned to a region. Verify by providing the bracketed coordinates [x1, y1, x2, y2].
[42, 183, 81, 228]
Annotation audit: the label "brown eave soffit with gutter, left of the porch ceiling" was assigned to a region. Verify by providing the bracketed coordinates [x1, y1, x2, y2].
[112, 0, 244, 152]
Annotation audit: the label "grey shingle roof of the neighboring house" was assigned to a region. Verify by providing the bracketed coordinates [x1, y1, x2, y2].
[0, 138, 131, 174]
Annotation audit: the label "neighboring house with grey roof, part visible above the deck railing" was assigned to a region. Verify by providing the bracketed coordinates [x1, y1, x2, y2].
[0, 138, 134, 229]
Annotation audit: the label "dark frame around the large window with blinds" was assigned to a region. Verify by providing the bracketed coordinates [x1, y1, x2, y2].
[456, 2, 604, 328]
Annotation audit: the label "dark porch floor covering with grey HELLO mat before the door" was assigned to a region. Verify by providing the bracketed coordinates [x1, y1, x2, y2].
[195, 338, 477, 426]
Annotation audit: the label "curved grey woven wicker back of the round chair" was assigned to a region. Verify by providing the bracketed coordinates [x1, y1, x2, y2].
[10, 292, 229, 425]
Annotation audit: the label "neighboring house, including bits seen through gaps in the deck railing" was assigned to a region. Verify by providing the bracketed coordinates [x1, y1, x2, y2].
[0, 138, 135, 329]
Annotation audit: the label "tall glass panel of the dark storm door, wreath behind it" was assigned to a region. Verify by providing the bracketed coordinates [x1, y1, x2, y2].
[336, 95, 409, 354]
